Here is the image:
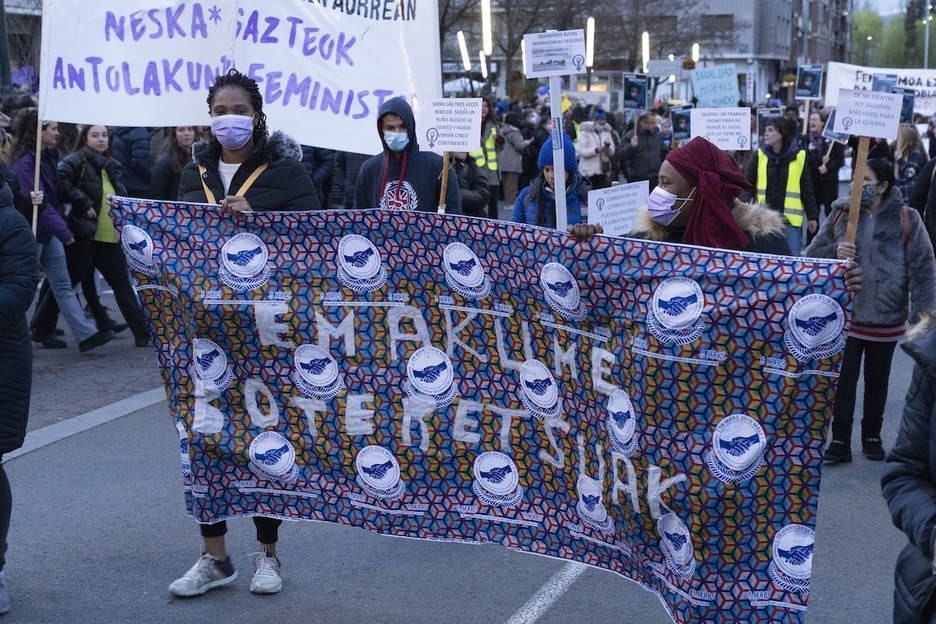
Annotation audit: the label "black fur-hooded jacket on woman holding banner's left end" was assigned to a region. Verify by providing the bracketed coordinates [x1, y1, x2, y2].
[179, 131, 322, 210]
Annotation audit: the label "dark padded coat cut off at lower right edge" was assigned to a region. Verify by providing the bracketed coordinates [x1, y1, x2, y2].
[881, 329, 936, 624]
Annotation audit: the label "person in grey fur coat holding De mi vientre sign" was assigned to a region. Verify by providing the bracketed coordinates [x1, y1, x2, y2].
[805, 158, 936, 464]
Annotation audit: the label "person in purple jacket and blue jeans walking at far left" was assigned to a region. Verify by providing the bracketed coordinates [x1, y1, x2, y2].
[10, 108, 114, 353]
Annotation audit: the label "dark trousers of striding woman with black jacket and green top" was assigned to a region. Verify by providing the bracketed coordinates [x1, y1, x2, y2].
[32, 238, 149, 336]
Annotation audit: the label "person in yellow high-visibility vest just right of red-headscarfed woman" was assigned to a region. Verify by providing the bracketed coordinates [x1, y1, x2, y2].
[745, 117, 819, 256]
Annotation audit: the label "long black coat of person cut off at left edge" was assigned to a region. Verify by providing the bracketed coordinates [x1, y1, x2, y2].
[0, 184, 39, 455]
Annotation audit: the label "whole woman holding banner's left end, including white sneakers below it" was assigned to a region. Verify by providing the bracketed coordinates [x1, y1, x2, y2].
[169, 69, 321, 596]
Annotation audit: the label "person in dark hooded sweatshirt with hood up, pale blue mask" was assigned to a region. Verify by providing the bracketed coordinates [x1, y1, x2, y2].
[354, 96, 462, 214]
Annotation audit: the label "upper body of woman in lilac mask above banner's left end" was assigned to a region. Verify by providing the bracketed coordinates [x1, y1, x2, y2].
[179, 69, 321, 213]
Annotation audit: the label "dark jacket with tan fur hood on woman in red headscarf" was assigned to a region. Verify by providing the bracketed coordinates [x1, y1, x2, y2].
[627, 201, 790, 256]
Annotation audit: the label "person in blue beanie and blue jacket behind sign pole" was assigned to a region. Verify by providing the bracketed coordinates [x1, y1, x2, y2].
[512, 133, 591, 228]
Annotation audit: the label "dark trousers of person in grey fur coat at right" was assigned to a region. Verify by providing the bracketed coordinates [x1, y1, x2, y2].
[832, 336, 897, 443]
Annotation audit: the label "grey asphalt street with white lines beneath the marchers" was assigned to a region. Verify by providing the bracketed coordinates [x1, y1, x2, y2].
[3, 288, 911, 624]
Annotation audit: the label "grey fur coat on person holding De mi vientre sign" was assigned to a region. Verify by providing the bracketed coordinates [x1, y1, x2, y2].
[803, 190, 936, 326]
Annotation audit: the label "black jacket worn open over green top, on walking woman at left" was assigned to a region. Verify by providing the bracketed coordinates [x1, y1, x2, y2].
[58, 147, 127, 216]
